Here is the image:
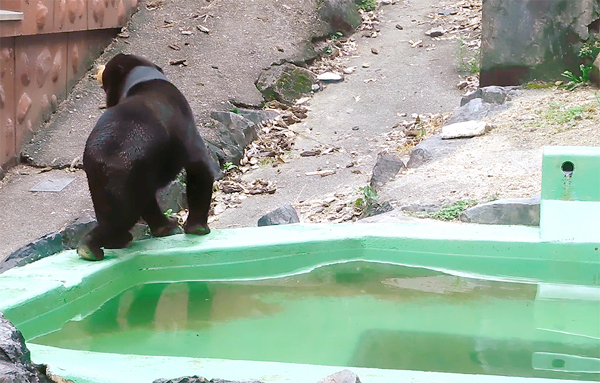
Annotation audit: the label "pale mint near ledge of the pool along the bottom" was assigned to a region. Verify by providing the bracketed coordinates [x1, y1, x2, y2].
[29, 344, 581, 383]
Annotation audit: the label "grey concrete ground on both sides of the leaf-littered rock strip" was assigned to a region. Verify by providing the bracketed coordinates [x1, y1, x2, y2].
[0, 0, 461, 261]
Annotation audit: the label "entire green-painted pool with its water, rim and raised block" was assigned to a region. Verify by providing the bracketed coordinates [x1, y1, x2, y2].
[0, 148, 600, 383]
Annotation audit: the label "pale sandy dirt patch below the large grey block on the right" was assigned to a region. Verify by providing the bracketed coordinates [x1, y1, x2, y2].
[382, 88, 600, 206]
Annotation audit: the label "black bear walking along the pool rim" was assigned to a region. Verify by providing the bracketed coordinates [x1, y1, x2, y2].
[77, 54, 215, 261]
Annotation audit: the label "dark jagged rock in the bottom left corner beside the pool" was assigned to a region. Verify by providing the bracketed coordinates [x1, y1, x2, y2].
[0, 313, 52, 383]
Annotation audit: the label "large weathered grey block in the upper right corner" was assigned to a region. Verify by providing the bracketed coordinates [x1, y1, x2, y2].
[480, 0, 600, 86]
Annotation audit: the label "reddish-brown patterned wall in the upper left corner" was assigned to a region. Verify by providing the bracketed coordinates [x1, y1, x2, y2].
[0, 0, 138, 166]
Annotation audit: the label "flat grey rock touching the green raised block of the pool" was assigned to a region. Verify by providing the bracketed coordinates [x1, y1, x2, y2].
[459, 196, 540, 226]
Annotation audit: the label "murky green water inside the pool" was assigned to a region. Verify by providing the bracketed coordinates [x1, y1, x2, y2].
[31, 262, 600, 381]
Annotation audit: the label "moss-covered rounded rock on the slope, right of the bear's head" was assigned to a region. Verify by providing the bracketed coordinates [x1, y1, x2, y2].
[256, 63, 317, 105]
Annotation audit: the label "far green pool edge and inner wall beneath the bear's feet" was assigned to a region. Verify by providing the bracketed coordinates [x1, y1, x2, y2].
[0, 222, 600, 339]
